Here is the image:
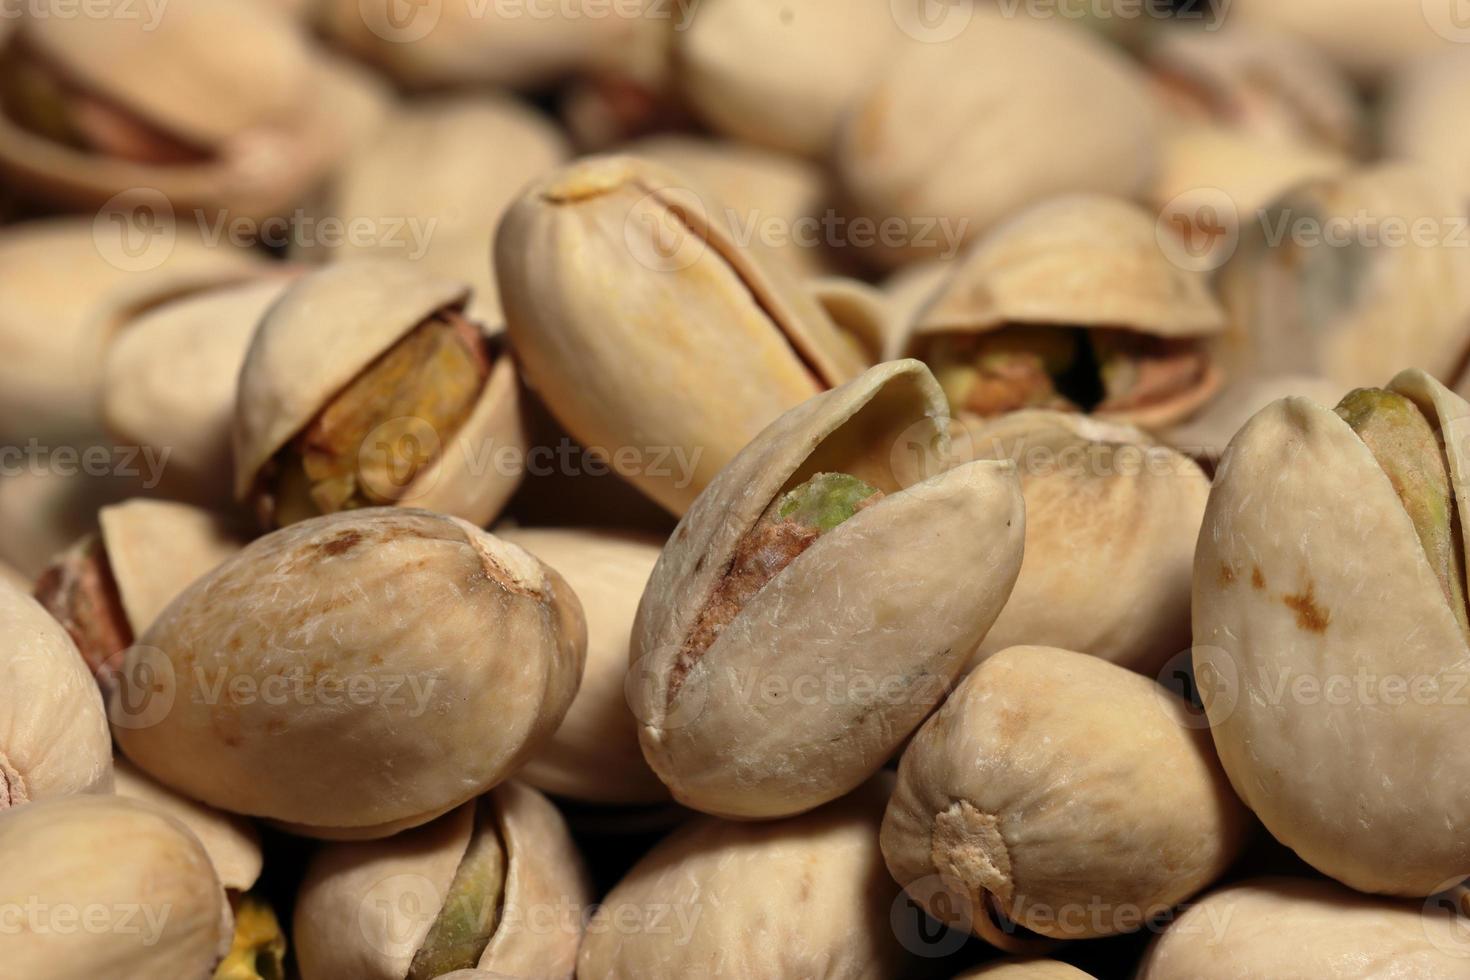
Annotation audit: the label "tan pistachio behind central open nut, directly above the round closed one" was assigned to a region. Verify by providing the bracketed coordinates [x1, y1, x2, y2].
[964, 411, 1210, 677]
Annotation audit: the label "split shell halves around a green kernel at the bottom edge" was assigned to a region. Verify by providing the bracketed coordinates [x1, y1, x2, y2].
[293, 780, 592, 980]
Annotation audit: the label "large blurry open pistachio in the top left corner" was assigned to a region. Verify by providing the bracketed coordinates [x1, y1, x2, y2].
[0, 0, 378, 219]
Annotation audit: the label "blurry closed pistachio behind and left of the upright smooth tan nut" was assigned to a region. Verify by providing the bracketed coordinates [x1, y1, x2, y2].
[295, 94, 569, 329]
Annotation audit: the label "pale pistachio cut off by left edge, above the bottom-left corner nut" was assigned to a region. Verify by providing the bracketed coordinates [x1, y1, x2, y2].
[0, 585, 112, 811]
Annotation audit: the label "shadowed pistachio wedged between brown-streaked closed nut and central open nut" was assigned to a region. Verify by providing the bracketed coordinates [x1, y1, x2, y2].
[495, 527, 669, 804]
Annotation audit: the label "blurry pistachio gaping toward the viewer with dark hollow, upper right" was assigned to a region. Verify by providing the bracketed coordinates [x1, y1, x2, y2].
[900, 195, 1225, 429]
